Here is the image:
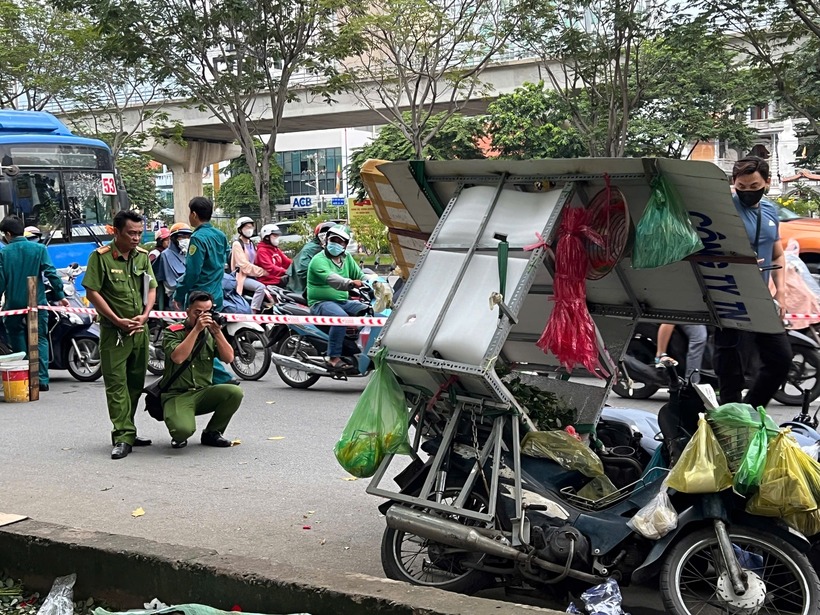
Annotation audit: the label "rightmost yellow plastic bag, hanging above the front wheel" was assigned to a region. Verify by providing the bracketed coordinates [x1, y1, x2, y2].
[746, 430, 817, 517]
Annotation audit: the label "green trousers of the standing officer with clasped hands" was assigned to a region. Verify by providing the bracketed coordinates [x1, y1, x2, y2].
[100, 326, 148, 445]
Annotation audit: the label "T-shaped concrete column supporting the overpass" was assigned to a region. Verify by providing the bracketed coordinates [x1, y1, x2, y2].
[144, 139, 242, 222]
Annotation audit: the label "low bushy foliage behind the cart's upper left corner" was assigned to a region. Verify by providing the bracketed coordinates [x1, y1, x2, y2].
[347, 114, 484, 199]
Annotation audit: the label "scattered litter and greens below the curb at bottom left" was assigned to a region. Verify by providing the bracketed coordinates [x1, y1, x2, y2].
[0, 572, 310, 615]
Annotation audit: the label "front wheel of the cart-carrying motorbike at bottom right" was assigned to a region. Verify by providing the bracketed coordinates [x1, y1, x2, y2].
[660, 526, 820, 615]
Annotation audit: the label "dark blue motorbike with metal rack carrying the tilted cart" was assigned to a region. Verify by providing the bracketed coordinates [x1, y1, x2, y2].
[368, 368, 820, 615]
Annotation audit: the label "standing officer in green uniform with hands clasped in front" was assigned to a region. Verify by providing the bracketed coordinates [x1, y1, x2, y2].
[83, 211, 157, 459]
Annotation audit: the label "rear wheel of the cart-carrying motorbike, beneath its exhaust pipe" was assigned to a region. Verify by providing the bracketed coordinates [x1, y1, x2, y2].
[382, 488, 494, 594]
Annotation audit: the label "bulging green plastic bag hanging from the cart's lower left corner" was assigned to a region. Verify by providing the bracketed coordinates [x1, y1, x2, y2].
[333, 348, 412, 478]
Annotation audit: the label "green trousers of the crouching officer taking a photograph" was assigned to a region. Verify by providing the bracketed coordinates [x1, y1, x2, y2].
[162, 384, 243, 442]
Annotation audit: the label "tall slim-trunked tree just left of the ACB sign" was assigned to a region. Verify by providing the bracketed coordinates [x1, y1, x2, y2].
[65, 0, 354, 221]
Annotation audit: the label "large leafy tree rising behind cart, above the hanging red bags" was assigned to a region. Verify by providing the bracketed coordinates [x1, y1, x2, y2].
[520, 0, 757, 157]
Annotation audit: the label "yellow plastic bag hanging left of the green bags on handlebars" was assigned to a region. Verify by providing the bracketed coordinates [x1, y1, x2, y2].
[667, 413, 732, 493]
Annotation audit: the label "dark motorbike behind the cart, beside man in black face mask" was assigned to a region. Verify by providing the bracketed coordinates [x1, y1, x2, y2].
[612, 323, 820, 406]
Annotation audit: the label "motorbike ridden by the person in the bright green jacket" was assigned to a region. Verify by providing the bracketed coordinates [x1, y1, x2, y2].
[268, 285, 390, 389]
